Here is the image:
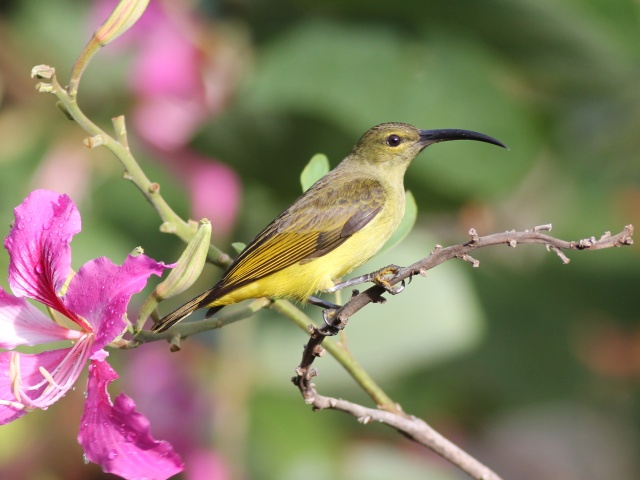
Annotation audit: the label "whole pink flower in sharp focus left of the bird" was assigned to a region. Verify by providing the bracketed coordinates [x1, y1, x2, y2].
[0, 190, 183, 479]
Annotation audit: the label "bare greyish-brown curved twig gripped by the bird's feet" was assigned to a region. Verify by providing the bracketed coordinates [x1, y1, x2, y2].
[292, 225, 633, 480]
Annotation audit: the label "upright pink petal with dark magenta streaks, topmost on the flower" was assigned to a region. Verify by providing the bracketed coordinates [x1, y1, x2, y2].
[4, 190, 80, 312]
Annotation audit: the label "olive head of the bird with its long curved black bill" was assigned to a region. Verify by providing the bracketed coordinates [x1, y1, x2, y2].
[352, 123, 507, 167]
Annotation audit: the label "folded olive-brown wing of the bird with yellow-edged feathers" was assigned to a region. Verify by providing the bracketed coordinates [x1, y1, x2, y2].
[220, 179, 384, 291]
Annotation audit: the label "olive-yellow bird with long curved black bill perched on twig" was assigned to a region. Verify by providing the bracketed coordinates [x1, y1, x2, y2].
[152, 123, 506, 332]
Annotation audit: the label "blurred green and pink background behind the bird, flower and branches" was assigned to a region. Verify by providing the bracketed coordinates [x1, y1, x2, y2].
[0, 0, 640, 480]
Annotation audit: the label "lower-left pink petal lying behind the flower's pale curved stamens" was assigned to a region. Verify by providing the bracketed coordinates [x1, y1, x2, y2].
[0, 348, 84, 425]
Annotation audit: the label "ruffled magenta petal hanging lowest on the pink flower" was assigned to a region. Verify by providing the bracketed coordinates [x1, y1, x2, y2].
[78, 361, 183, 480]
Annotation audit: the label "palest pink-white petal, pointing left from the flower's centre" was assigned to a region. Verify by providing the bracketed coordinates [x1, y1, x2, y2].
[0, 288, 82, 349]
